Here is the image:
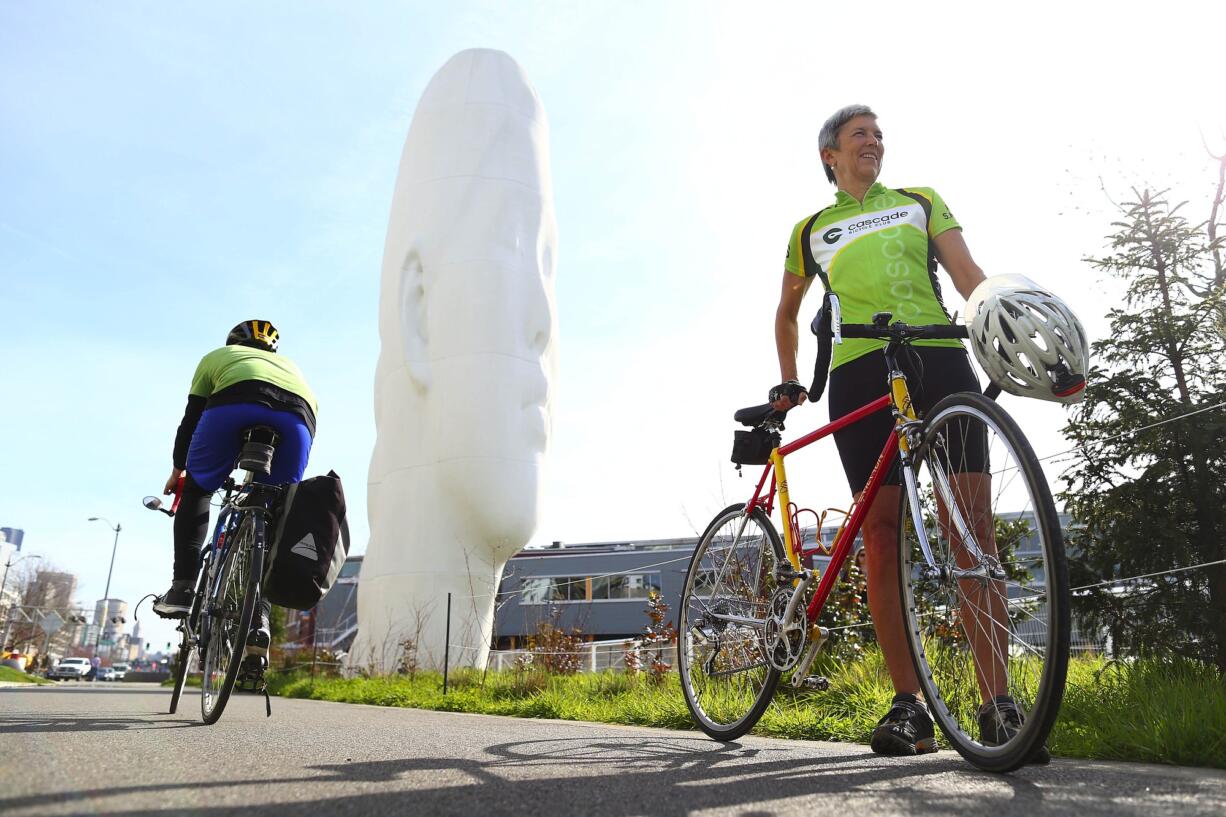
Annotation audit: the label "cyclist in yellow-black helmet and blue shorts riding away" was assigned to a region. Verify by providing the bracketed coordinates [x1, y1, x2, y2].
[153, 320, 318, 659]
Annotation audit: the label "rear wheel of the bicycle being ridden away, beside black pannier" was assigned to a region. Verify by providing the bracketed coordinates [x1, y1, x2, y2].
[200, 513, 264, 724]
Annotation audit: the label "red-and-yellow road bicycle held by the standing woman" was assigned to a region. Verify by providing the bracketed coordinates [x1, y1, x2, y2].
[678, 313, 1070, 772]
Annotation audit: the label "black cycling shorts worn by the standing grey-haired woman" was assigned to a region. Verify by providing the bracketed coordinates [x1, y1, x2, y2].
[829, 346, 988, 493]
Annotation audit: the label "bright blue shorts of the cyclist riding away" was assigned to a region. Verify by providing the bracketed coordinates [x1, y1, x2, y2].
[188, 402, 311, 492]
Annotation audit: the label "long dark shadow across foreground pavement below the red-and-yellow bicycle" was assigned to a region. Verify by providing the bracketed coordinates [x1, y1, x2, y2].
[9, 719, 1226, 817]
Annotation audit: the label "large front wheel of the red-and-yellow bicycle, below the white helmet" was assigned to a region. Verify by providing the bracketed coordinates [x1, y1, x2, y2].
[899, 393, 1072, 772]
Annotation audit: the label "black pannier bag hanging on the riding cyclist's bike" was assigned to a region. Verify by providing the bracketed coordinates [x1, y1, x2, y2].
[262, 471, 349, 610]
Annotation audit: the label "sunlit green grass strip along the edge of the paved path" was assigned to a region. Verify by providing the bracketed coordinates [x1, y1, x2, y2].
[258, 650, 1226, 768]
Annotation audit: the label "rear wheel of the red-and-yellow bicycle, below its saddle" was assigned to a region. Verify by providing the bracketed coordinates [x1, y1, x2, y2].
[677, 503, 786, 741]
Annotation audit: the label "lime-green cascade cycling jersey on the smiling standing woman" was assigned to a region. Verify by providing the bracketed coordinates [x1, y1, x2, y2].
[783, 183, 962, 369]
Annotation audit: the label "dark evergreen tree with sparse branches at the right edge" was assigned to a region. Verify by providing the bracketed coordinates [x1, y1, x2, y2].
[1062, 164, 1226, 672]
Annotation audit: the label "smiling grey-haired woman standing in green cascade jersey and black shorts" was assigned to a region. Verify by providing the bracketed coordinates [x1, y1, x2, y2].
[770, 105, 1085, 762]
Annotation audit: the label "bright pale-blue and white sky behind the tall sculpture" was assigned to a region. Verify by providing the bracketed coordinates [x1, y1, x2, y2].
[0, 0, 1226, 642]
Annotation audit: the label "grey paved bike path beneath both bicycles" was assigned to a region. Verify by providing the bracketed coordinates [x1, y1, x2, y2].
[0, 683, 1226, 817]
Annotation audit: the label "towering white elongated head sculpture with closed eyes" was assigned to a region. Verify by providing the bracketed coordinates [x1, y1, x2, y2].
[349, 49, 557, 671]
